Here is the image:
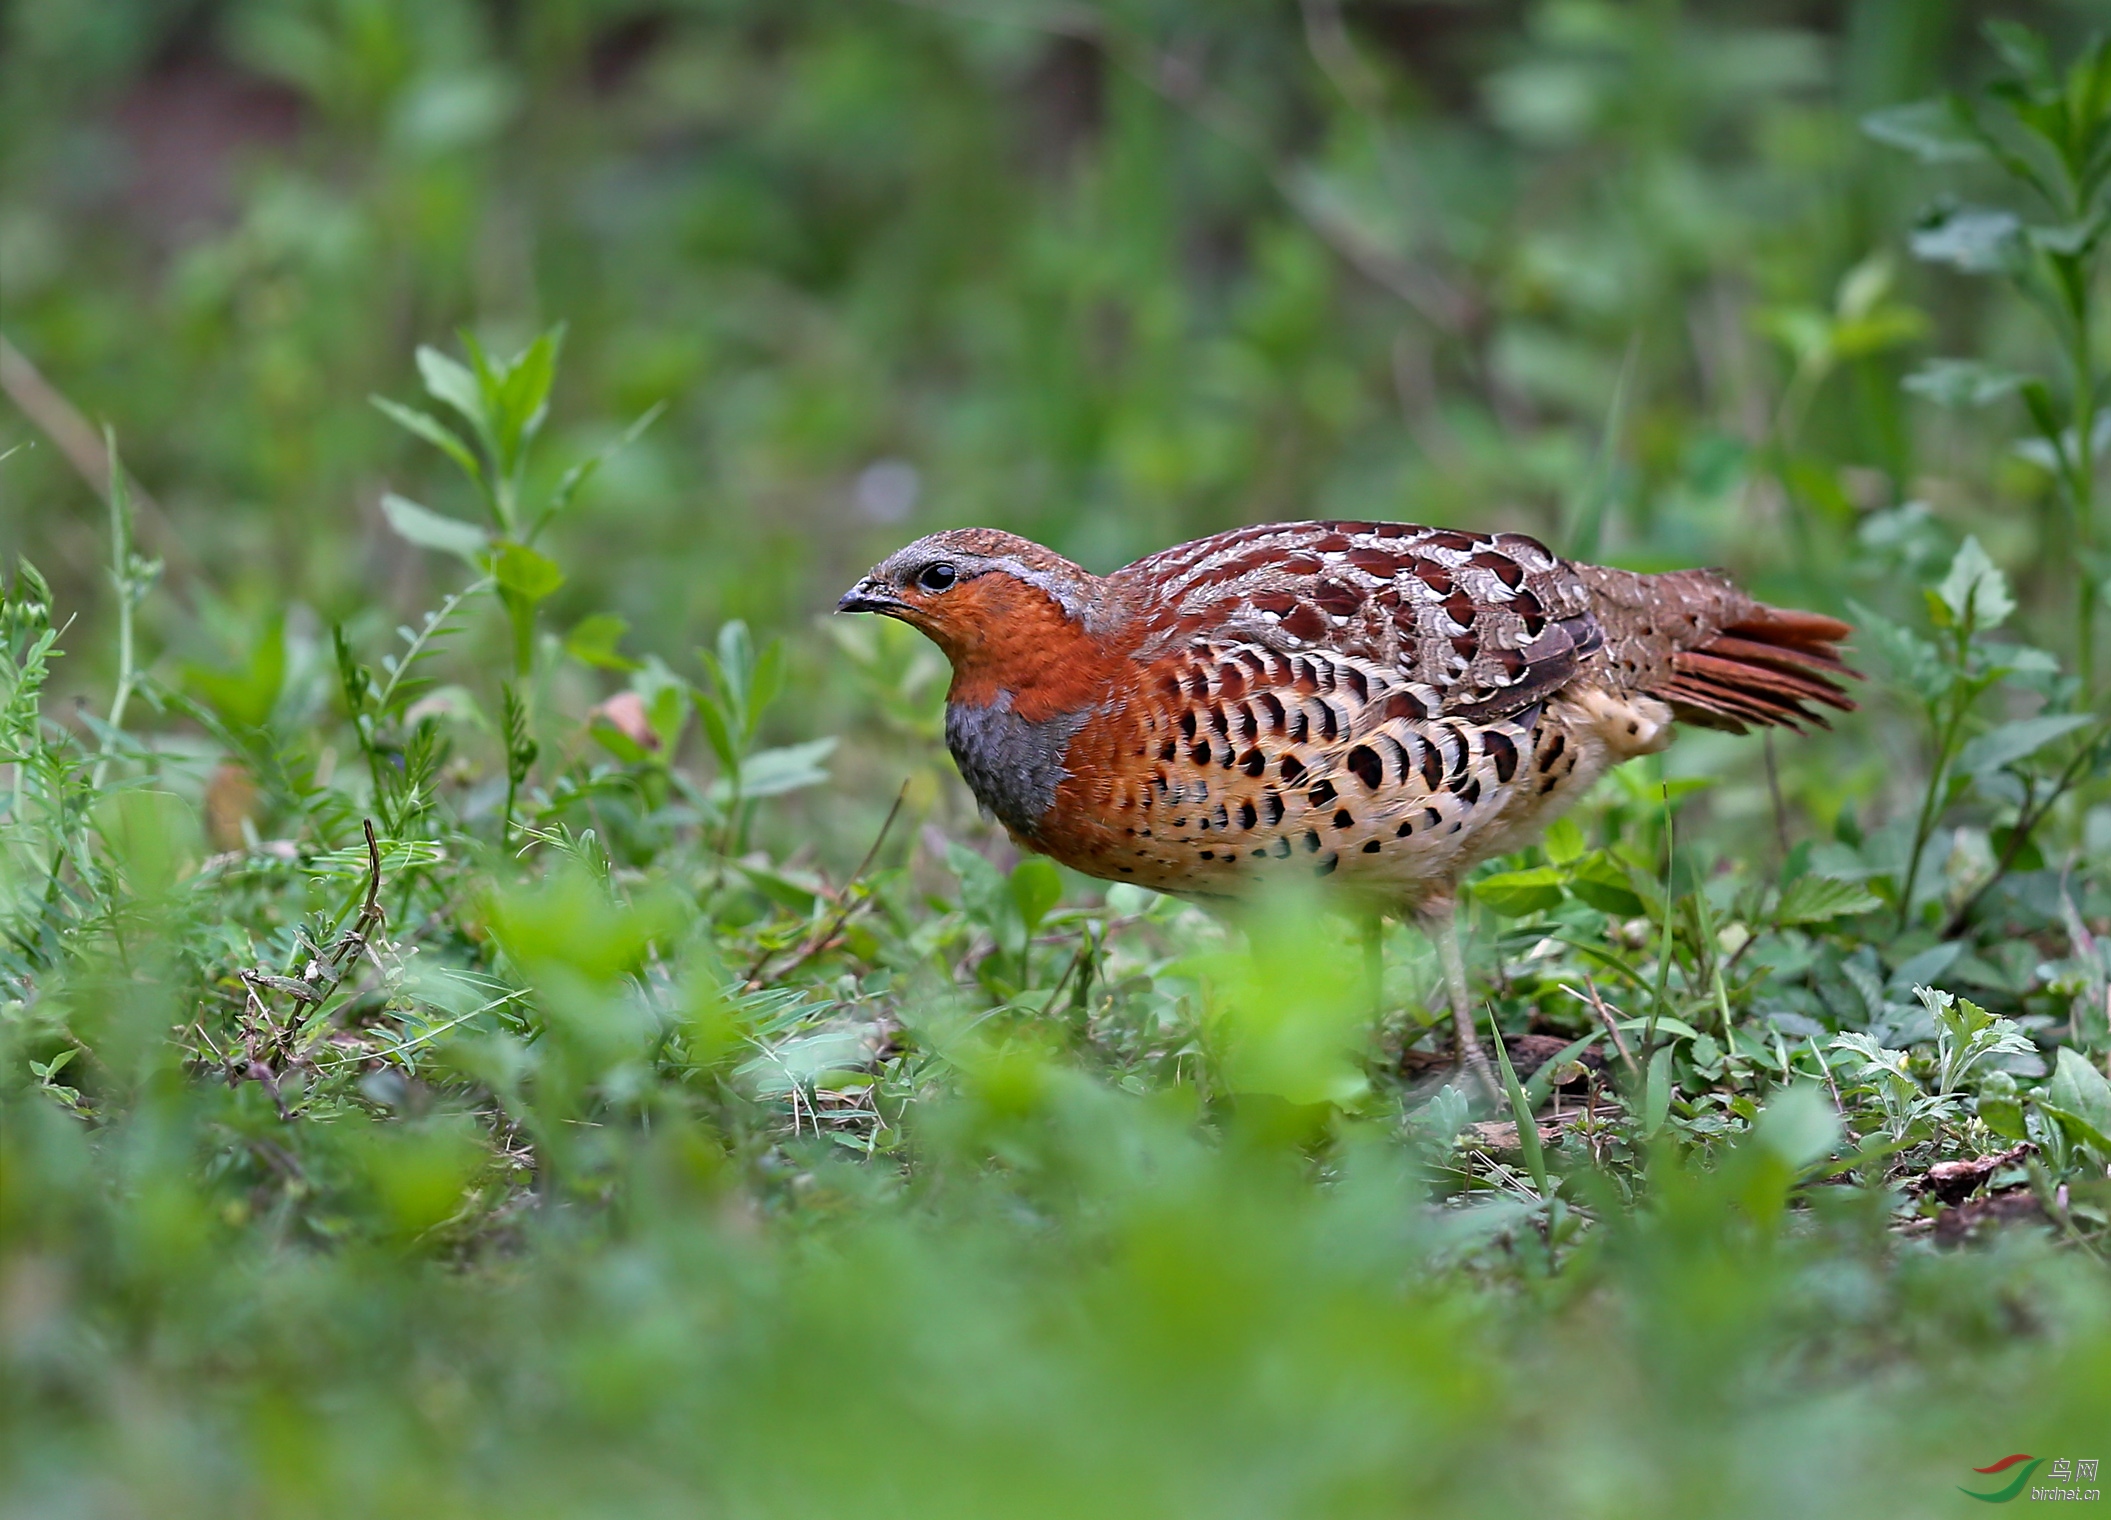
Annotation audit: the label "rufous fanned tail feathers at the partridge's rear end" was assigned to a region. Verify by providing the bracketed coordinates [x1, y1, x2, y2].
[1657, 602, 1862, 733]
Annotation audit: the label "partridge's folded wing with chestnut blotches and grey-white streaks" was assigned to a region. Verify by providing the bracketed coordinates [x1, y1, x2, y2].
[1108, 521, 1604, 720]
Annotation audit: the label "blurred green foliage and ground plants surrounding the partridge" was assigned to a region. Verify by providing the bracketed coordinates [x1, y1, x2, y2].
[0, 0, 2111, 1518]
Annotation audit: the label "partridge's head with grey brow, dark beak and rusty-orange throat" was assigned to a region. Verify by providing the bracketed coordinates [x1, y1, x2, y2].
[836, 528, 1108, 692]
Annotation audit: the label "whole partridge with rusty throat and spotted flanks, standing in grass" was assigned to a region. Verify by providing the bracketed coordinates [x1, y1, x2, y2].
[836, 521, 1856, 1083]
